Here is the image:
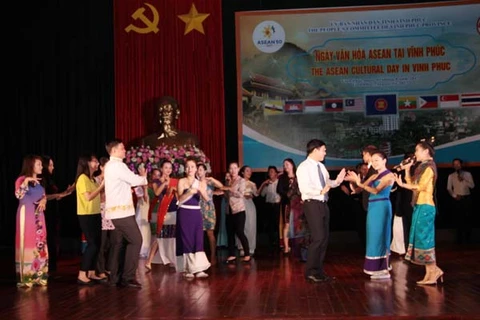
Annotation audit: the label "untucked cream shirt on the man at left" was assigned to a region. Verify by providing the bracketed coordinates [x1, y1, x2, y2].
[105, 157, 148, 219]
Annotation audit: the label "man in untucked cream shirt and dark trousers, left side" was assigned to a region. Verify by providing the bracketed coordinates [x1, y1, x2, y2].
[105, 139, 148, 288]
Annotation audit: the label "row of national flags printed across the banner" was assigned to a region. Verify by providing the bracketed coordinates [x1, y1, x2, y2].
[262, 92, 480, 116]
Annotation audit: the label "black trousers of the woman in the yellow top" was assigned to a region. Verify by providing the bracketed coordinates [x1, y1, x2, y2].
[78, 213, 102, 272]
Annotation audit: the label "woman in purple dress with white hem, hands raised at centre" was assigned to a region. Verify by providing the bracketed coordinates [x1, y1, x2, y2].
[176, 159, 210, 279]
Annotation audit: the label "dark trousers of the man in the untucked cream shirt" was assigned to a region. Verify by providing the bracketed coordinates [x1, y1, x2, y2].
[108, 216, 143, 283]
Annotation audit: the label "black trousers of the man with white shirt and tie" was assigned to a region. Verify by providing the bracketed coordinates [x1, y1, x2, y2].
[303, 200, 330, 277]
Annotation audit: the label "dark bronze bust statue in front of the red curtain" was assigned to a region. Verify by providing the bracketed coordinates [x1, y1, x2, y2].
[134, 96, 199, 148]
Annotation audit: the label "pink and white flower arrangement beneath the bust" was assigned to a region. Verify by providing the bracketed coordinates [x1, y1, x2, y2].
[125, 144, 211, 178]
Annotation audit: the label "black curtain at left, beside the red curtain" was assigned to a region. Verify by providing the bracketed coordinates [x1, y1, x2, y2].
[0, 0, 115, 252]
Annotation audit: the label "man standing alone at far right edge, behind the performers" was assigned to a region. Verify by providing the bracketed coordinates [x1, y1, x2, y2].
[447, 158, 475, 244]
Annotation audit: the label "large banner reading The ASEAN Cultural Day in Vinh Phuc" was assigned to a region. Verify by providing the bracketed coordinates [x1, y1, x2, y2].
[236, 1, 480, 169]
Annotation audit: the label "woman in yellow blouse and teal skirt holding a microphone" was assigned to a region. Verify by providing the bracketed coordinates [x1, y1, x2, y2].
[395, 141, 443, 284]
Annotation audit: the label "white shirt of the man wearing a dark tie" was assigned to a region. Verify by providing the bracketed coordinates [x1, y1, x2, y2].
[297, 158, 339, 201]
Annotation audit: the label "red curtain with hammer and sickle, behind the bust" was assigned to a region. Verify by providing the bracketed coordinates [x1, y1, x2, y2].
[114, 0, 226, 177]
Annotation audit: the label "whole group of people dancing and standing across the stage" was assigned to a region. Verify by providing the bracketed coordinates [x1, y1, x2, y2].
[15, 139, 473, 287]
